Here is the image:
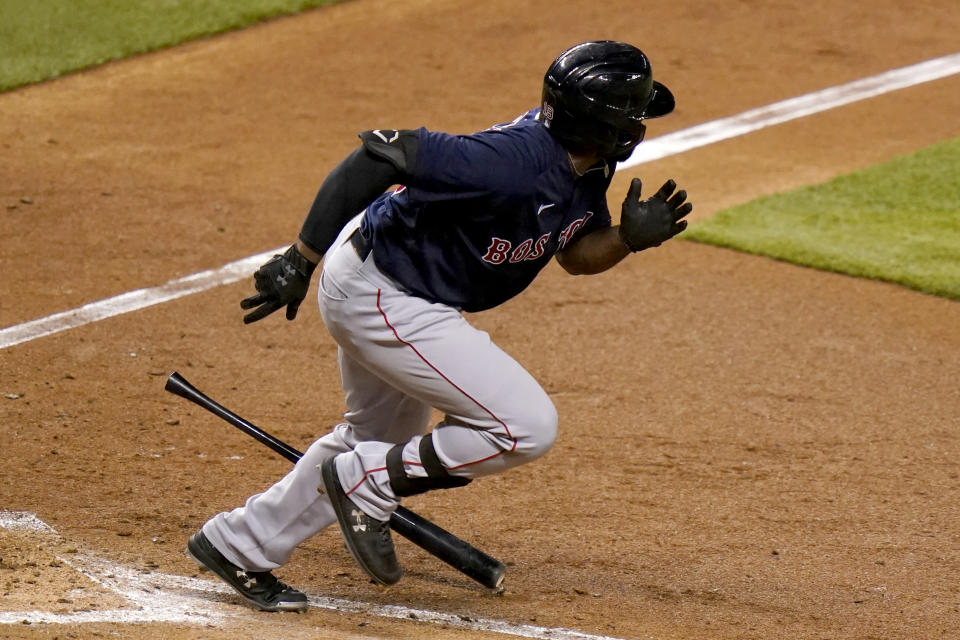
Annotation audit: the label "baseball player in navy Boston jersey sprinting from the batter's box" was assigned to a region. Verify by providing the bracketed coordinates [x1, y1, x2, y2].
[188, 41, 692, 611]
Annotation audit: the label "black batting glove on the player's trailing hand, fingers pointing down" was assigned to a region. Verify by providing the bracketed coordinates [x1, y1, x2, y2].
[240, 245, 317, 324]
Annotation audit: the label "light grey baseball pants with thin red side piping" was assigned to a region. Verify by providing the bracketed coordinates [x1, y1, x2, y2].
[203, 216, 557, 571]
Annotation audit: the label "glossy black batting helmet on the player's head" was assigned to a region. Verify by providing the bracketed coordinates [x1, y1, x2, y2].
[540, 40, 674, 160]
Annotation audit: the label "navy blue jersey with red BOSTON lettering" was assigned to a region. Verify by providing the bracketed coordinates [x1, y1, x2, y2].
[361, 109, 613, 311]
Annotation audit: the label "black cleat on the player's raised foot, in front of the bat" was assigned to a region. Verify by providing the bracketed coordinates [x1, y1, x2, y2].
[320, 458, 403, 585]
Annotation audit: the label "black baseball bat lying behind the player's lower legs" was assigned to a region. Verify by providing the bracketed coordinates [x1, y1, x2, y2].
[164, 371, 506, 589]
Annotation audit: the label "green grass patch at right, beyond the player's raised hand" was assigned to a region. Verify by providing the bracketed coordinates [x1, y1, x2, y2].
[683, 138, 960, 300]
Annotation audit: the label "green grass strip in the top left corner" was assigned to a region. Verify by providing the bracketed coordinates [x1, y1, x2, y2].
[0, 0, 337, 91]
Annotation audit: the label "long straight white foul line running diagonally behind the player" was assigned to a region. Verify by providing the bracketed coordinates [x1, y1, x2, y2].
[0, 53, 960, 349]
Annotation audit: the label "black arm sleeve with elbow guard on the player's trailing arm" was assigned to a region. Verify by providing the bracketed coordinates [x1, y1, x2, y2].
[299, 130, 418, 254]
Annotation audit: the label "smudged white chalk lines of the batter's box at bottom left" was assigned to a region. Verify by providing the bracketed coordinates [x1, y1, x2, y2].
[0, 510, 632, 640]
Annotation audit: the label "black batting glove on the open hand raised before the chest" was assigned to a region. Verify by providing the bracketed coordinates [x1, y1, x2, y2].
[620, 178, 693, 251]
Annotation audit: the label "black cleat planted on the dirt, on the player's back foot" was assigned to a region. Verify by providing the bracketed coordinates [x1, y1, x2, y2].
[187, 531, 307, 613]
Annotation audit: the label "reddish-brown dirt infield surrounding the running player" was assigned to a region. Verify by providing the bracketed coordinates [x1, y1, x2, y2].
[0, 0, 960, 640]
